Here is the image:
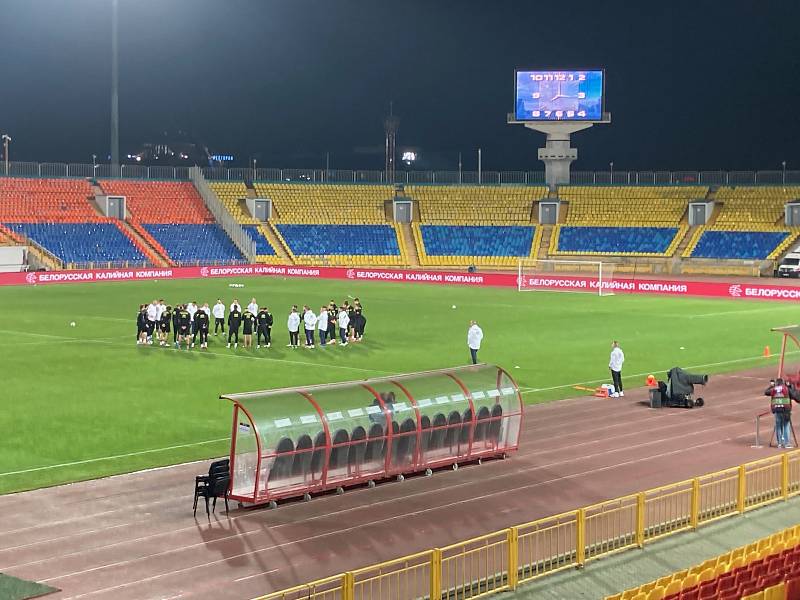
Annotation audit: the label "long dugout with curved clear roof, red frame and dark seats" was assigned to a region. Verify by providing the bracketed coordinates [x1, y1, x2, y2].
[221, 364, 522, 504]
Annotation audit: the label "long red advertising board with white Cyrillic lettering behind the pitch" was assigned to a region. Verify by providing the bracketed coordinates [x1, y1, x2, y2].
[0, 265, 800, 300]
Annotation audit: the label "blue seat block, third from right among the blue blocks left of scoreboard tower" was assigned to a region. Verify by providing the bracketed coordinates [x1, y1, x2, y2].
[278, 224, 400, 256]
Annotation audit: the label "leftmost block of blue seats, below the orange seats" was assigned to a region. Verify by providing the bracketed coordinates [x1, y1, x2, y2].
[6, 223, 147, 263]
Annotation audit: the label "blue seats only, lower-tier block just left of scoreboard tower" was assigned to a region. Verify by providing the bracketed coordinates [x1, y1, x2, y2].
[419, 225, 536, 256]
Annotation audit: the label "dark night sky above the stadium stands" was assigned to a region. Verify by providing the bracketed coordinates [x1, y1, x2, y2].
[0, 0, 800, 170]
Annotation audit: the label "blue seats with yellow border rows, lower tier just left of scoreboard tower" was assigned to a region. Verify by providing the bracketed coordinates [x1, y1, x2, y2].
[413, 224, 536, 266]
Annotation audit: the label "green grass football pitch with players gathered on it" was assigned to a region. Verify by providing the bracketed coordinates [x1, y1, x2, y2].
[0, 278, 800, 493]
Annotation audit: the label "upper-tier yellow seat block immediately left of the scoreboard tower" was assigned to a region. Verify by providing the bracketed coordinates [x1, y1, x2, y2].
[405, 185, 547, 225]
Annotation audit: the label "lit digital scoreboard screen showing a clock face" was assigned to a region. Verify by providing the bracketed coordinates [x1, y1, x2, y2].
[514, 70, 605, 121]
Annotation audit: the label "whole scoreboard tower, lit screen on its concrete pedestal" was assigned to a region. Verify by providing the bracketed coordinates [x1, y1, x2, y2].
[506, 69, 611, 188]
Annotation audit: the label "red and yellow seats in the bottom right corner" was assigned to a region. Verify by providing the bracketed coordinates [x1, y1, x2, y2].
[606, 525, 800, 600]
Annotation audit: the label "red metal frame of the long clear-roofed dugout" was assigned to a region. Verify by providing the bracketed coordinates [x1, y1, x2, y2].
[222, 367, 523, 504]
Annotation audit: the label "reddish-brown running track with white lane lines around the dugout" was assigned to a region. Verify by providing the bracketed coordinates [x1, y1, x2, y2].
[0, 367, 788, 600]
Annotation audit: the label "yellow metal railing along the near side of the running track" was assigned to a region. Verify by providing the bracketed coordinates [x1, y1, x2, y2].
[257, 450, 800, 600]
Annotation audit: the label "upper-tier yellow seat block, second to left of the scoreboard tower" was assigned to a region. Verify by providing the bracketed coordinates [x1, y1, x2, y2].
[254, 182, 394, 224]
